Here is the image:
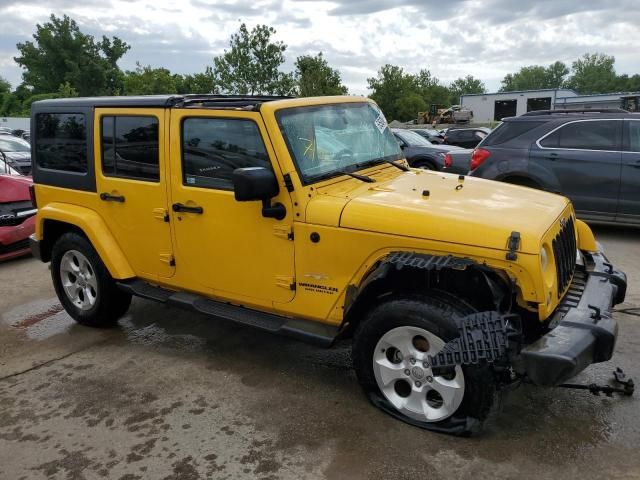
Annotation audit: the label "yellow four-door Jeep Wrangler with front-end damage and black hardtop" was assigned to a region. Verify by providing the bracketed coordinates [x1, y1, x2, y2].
[31, 95, 626, 434]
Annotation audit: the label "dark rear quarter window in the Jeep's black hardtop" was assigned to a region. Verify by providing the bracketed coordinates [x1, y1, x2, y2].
[35, 113, 87, 173]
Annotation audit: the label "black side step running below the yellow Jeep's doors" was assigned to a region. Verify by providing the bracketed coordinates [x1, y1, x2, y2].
[118, 280, 340, 347]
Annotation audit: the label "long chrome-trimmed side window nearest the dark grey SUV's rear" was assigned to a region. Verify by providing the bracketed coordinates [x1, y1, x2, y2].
[540, 120, 620, 150]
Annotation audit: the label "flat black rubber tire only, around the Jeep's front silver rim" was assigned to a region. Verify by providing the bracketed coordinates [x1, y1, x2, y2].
[352, 290, 496, 435]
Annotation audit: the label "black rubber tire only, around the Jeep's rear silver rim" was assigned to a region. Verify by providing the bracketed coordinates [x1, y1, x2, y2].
[51, 232, 131, 328]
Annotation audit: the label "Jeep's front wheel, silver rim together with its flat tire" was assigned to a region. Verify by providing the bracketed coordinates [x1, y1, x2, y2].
[353, 292, 495, 434]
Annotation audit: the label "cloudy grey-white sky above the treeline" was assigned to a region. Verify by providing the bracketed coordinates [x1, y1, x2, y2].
[0, 0, 640, 94]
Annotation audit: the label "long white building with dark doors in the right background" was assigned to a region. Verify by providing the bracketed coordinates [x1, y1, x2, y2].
[460, 88, 633, 123]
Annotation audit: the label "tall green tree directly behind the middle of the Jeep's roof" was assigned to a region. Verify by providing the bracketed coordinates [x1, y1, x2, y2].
[213, 23, 295, 95]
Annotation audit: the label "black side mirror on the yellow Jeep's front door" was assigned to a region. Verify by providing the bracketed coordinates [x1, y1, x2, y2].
[231, 167, 287, 220]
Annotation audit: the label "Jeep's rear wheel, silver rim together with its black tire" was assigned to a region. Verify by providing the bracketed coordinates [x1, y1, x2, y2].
[51, 233, 131, 327]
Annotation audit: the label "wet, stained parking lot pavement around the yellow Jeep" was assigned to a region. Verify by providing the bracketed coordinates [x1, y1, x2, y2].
[0, 227, 640, 480]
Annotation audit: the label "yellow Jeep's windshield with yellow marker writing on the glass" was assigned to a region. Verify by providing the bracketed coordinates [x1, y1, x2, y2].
[277, 103, 402, 184]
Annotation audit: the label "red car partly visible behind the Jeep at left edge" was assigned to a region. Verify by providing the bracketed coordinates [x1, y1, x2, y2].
[0, 173, 36, 261]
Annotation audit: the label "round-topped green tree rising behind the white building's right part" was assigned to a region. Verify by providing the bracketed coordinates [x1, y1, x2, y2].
[567, 53, 618, 95]
